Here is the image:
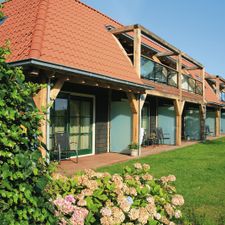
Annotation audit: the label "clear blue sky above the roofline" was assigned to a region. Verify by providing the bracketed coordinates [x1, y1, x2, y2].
[81, 0, 225, 78]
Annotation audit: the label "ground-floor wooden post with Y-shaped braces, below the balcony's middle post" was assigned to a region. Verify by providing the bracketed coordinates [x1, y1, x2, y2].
[174, 99, 185, 146]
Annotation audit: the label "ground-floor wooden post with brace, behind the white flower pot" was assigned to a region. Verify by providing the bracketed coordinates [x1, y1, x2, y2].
[127, 92, 139, 143]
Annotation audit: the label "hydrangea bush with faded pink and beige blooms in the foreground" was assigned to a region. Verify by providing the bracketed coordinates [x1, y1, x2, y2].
[48, 163, 189, 225]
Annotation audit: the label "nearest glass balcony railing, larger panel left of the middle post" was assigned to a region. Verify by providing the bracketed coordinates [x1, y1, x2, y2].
[141, 56, 178, 87]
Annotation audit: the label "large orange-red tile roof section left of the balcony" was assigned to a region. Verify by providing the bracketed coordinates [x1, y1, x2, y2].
[0, 0, 142, 84]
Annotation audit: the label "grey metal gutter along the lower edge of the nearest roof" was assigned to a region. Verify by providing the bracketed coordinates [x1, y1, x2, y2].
[9, 59, 154, 90]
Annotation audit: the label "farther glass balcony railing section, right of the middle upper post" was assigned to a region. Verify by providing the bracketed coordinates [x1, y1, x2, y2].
[181, 74, 203, 95]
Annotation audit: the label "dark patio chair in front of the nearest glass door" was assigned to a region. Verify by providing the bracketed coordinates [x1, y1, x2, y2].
[52, 133, 78, 163]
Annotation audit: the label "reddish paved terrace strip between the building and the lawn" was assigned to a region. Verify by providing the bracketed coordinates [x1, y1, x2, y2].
[57, 136, 222, 176]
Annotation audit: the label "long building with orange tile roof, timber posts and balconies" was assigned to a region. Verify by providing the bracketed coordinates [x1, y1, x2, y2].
[0, 0, 225, 158]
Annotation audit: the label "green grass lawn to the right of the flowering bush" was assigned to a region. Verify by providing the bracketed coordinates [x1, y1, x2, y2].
[98, 138, 225, 225]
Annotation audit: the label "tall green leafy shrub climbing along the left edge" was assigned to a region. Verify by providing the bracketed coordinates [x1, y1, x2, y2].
[0, 45, 55, 225]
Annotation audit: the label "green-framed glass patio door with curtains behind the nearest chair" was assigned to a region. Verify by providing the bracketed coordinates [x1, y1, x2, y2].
[50, 94, 93, 157]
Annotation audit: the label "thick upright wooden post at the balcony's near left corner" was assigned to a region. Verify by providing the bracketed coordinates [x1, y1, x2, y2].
[133, 28, 141, 78]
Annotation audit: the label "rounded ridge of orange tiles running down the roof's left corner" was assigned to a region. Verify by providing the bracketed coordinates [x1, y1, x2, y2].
[29, 0, 49, 58]
